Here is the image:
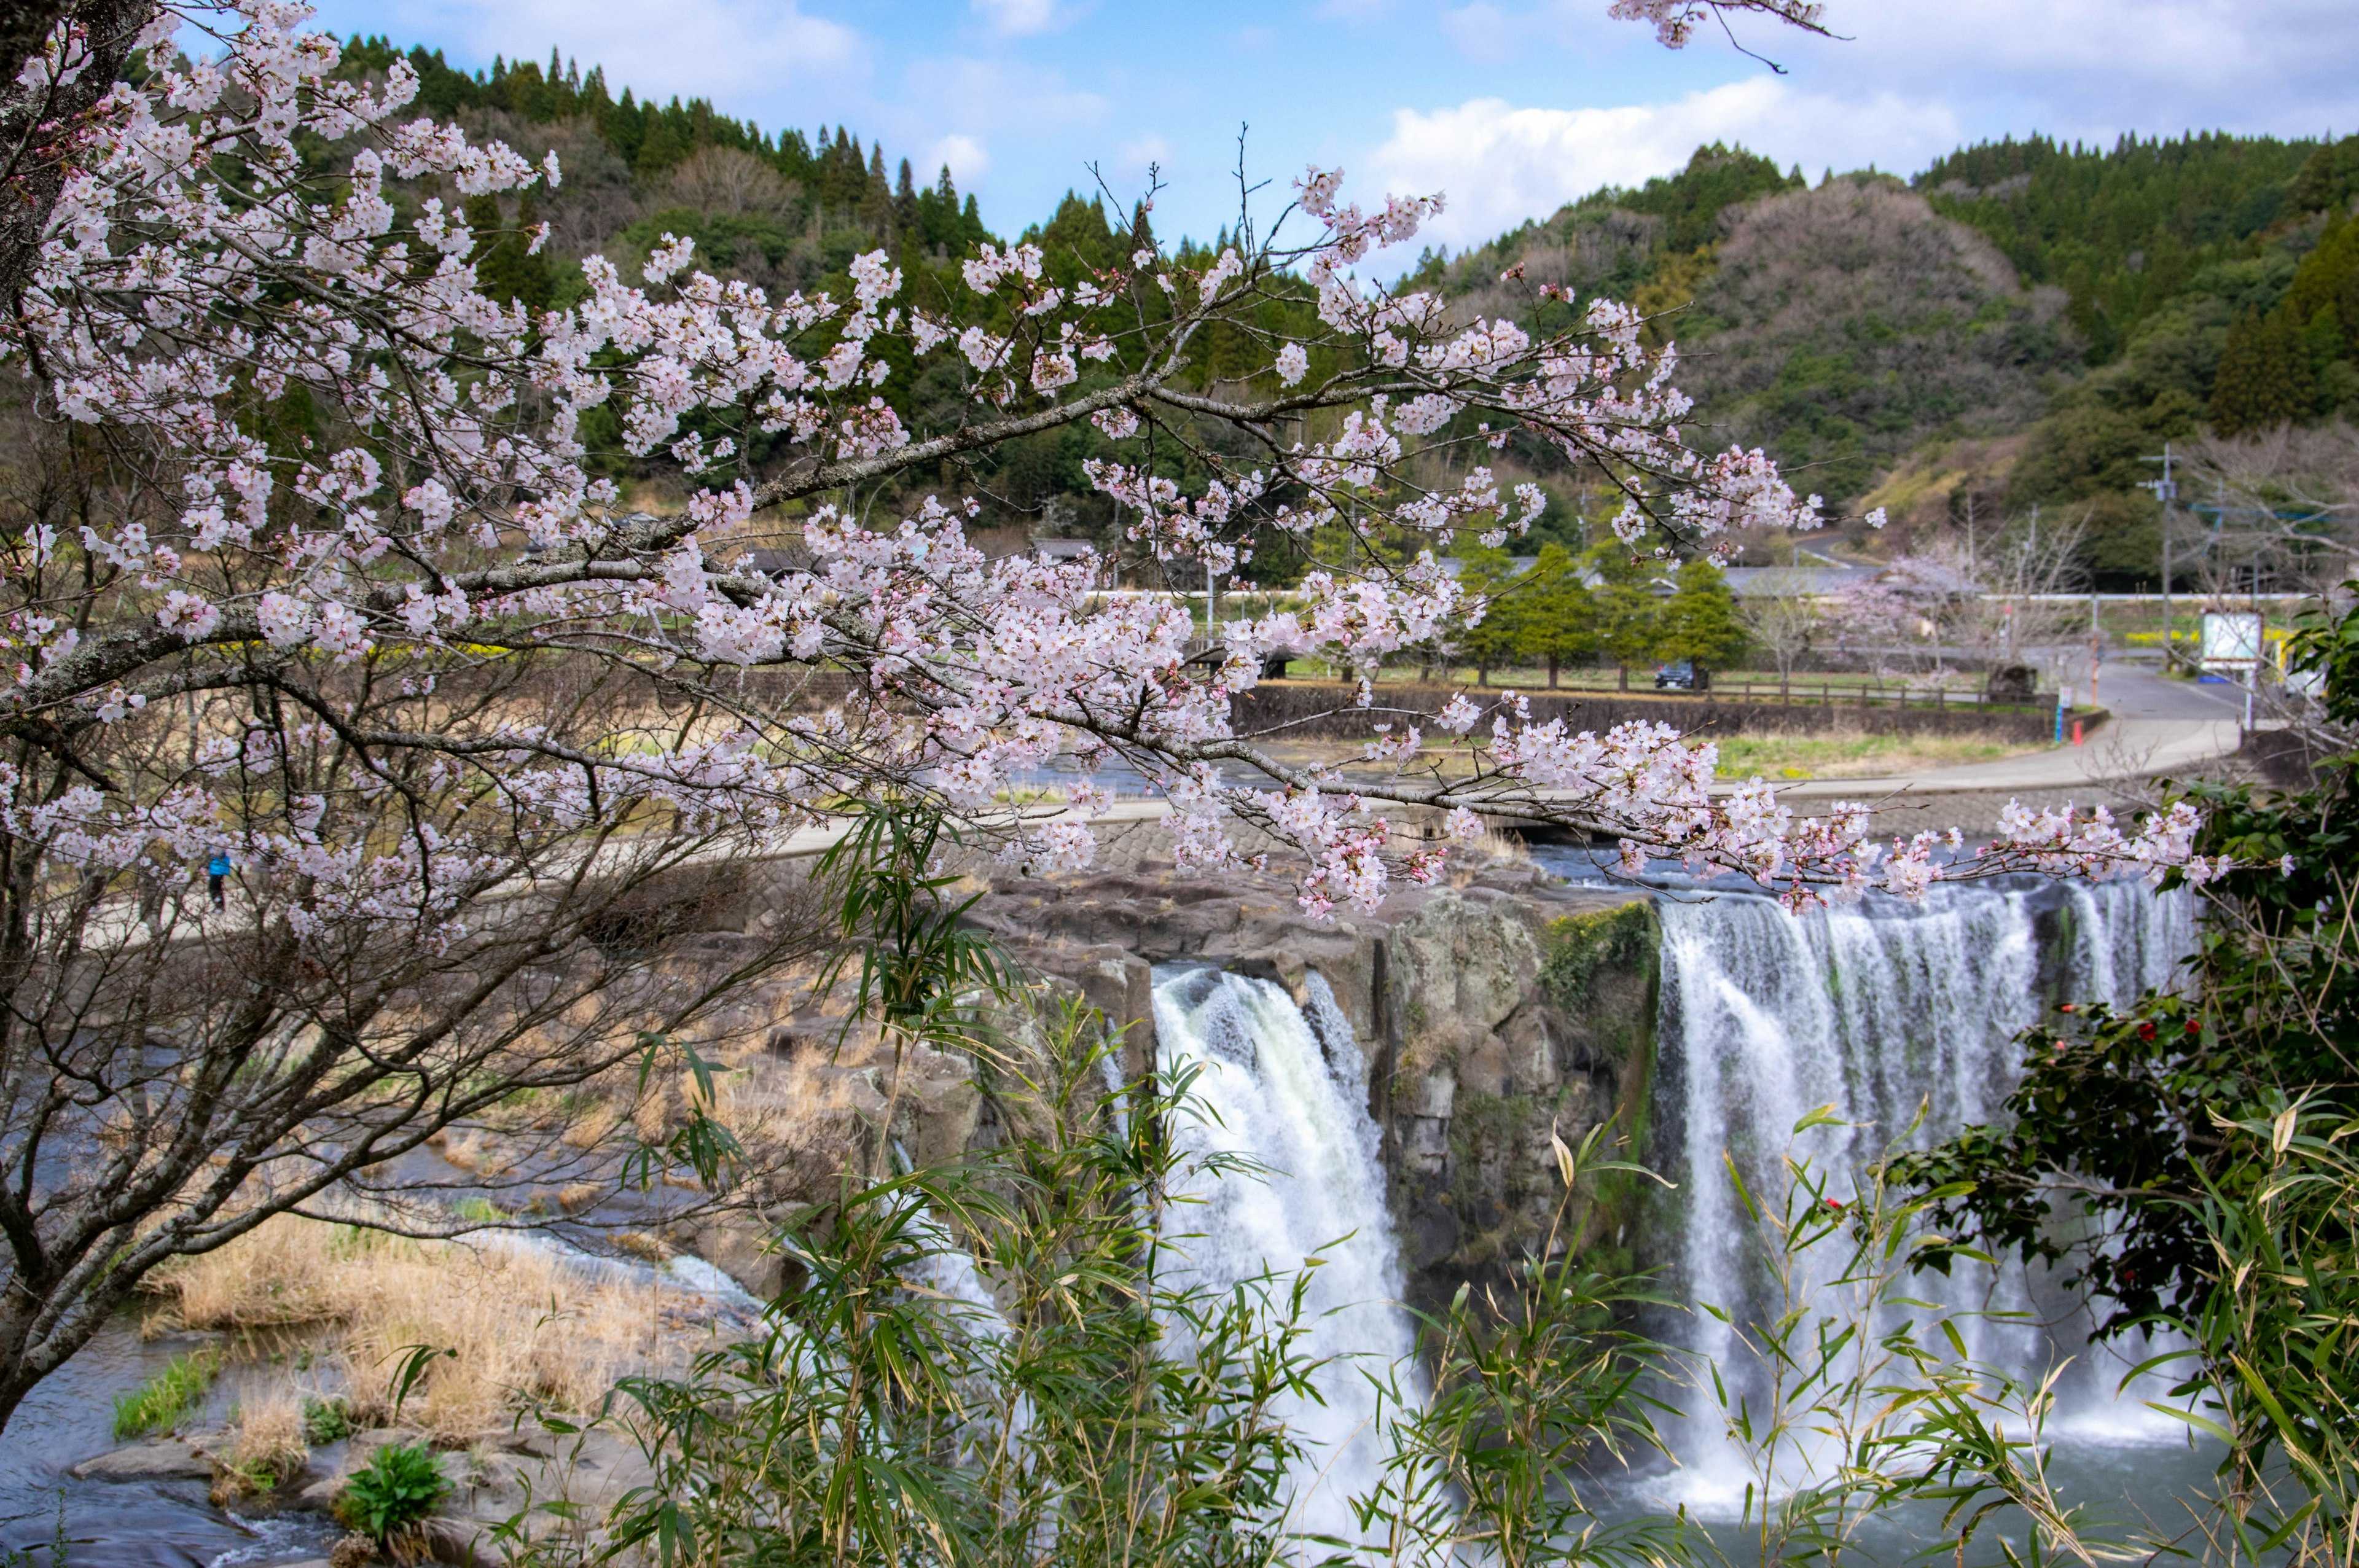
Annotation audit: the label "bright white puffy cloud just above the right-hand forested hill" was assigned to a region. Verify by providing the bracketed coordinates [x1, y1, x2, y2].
[1352, 76, 1958, 248]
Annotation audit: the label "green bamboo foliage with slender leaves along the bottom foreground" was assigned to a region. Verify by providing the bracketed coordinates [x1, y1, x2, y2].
[488, 809, 2359, 1568]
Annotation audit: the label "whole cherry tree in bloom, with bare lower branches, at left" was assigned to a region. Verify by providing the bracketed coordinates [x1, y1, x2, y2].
[0, 0, 2208, 1414]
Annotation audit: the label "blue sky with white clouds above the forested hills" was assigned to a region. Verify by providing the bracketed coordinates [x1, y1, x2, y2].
[304, 0, 2359, 248]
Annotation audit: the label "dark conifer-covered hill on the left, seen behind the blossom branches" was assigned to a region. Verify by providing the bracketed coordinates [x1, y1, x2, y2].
[321, 37, 1333, 568]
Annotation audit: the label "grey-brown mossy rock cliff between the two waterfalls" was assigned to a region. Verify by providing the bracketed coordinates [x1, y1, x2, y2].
[958, 863, 1659, 1306]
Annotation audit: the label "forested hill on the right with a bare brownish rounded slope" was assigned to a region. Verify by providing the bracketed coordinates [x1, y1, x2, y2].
[1415, 135, 2359, 585]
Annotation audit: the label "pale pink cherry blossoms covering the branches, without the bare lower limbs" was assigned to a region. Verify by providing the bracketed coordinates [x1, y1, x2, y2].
[0, 0, 2220, 931]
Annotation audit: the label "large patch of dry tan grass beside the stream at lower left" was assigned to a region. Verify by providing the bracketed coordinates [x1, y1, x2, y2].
[160, 1217, 696, 1443]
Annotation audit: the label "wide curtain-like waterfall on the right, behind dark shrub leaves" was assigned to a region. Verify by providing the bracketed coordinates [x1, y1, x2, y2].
[1654, 882, 2194, 1511]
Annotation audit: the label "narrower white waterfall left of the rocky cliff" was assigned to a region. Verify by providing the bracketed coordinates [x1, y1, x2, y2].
[1156, 967, 1415, 1535]
